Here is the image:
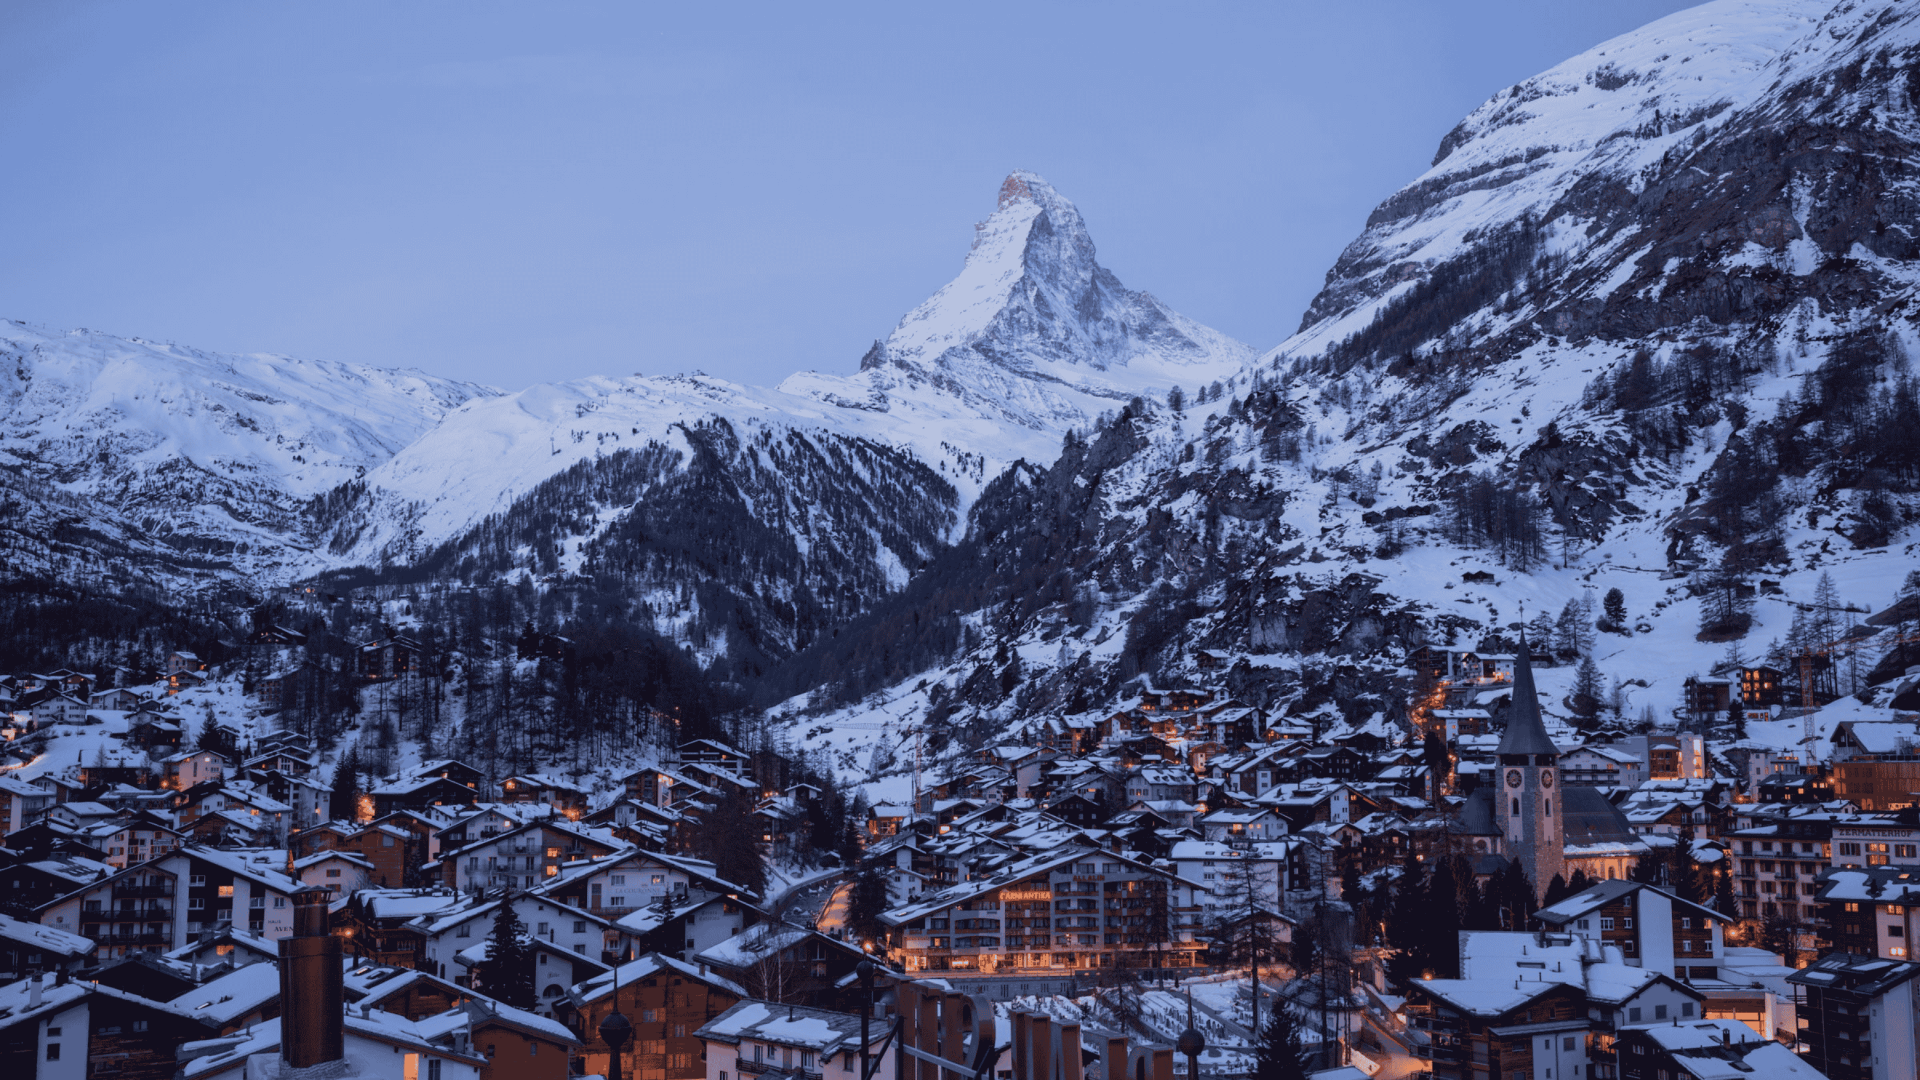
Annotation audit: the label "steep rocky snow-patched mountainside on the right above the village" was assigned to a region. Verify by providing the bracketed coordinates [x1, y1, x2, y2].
[772, 0, 1920, 794]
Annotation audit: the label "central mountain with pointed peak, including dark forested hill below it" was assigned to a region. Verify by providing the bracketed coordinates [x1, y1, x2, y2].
[307, 173, 1252, 676]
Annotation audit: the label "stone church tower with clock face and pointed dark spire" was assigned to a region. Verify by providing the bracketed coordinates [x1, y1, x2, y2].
[1494, 638, 1567, 896]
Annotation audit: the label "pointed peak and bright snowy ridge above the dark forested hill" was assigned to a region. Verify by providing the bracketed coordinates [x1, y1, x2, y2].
[334, 173, 1252, 565]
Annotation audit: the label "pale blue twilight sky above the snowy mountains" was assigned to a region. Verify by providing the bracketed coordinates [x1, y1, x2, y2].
[0, 0, 1686, 388]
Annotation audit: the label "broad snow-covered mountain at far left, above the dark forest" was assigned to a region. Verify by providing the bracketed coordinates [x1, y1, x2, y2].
[0, 323, 497, 588]
